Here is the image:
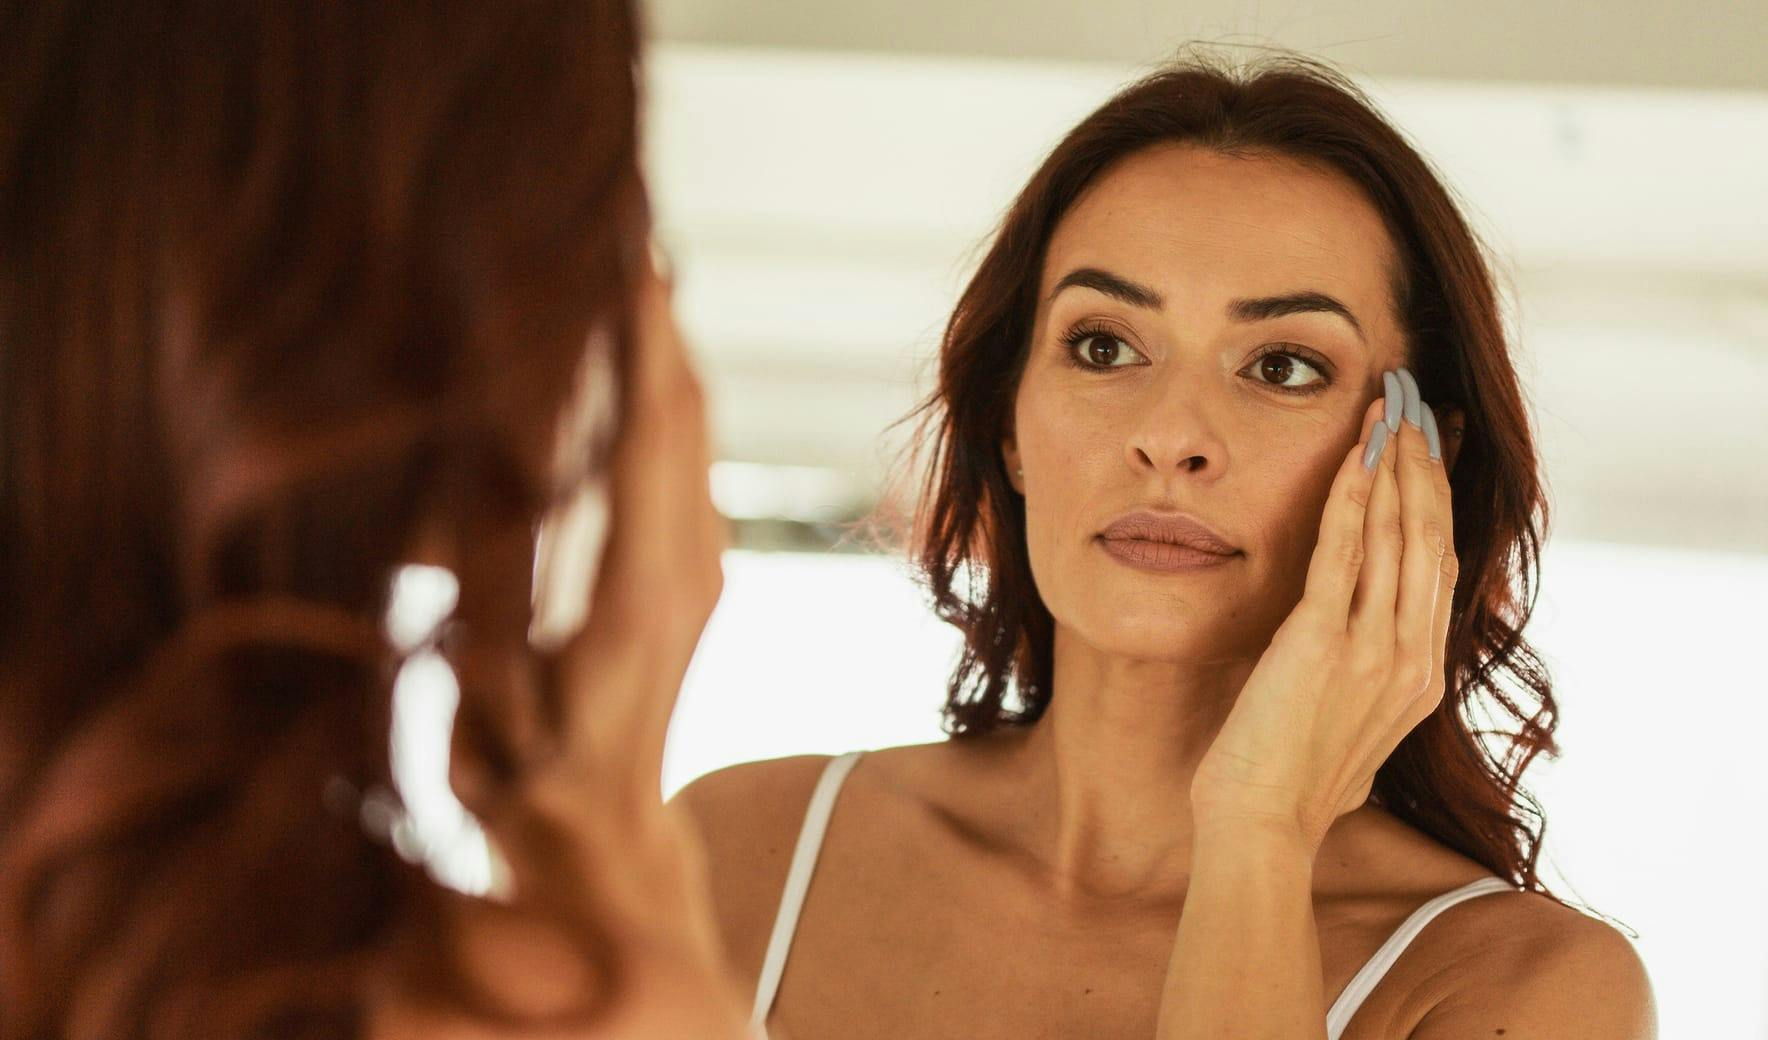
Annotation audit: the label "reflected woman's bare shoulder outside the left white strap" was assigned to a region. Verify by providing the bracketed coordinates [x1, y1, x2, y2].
[670, 755, 848, 980]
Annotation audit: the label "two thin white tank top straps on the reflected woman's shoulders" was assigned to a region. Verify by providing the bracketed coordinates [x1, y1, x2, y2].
[750, 752, 1520, 1040]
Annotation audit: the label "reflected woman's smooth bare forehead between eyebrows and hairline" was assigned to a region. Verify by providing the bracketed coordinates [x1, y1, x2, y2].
[1040, 147, 1393, 308]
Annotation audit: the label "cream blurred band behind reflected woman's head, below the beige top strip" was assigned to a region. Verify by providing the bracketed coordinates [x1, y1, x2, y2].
[647, 42, 1768, 552]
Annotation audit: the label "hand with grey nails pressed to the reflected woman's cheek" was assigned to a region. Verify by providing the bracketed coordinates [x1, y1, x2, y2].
[1192, 370, 1457, 851]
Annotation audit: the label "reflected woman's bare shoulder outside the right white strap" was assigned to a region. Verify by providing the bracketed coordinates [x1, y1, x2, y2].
[1409, 891, 1657, 1040]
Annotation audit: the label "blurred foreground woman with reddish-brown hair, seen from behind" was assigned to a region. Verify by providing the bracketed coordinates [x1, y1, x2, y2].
[0, 0, 743, 1040]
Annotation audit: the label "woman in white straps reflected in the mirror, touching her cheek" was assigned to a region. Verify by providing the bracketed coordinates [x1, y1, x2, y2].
[681, 52, 1653, 1040]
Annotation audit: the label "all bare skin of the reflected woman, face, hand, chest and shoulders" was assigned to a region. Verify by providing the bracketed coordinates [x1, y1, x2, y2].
[681, 147, 1651, 1040]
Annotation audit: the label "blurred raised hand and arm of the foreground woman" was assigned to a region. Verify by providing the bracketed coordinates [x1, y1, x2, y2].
[433, 247, 746, 1040]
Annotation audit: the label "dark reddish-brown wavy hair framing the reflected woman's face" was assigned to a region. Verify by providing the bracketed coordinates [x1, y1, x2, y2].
[912, 55, 1558, 891]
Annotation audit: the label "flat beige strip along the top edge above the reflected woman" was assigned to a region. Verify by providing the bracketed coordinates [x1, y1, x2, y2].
[645, 0, 1768, 90]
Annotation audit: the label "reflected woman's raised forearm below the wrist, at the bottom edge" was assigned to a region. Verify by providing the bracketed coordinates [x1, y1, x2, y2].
[1155, 824, 1326, 1040]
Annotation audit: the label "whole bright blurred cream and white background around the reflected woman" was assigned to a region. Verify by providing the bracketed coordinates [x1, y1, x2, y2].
[401, 0, 1768, 1038]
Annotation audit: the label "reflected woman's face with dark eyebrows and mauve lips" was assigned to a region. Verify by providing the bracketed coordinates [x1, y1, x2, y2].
[1002, 145, 1404, 661]
